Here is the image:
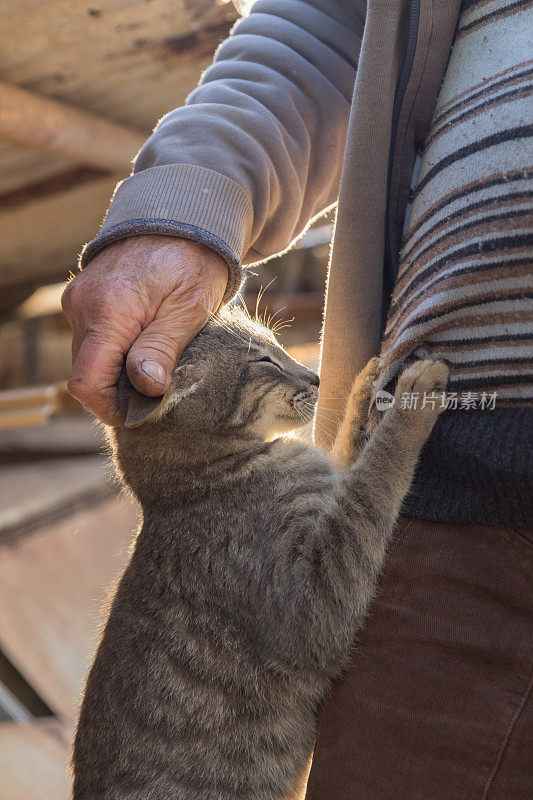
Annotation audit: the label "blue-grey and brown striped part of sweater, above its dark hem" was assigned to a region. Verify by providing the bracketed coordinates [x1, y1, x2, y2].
[381, 0, 533, 407]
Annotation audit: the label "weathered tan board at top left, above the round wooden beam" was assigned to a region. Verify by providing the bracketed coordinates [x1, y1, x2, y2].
[0, 0, 236, 129]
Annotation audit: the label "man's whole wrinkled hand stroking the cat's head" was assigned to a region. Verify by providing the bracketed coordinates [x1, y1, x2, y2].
[62, 235, 228, 425]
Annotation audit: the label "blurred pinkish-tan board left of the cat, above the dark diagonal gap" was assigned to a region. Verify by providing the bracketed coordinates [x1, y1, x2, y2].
[0, 494, 138, 720]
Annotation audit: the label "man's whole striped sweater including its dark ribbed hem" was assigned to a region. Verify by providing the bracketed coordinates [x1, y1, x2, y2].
[381, 0, 533, 524]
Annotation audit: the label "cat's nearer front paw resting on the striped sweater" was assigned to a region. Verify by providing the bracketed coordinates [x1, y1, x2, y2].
[395, 359, 450, 415]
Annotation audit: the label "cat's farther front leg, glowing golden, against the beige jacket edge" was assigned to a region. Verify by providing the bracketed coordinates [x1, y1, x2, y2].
[330, 358, 379, 467]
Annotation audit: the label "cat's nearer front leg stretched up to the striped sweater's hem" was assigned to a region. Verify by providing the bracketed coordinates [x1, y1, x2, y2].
[284, 361, 448, 671]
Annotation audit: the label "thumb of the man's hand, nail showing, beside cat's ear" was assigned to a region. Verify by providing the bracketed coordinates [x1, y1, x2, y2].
[126, 317, 195, 397]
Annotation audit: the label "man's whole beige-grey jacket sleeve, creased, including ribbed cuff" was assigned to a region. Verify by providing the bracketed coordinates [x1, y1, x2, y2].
[81, 0, 366, 300]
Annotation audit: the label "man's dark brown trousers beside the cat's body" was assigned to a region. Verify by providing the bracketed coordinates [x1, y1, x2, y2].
[306, 519, 533, 800]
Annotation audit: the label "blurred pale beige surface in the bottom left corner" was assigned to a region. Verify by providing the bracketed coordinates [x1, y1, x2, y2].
[0, 719, 70, 800]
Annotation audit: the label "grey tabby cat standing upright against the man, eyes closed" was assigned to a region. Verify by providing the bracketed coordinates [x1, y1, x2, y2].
[73, 309, 448, 800]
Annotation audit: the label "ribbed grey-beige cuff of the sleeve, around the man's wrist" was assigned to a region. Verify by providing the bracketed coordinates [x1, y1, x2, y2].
[80, 164, 253, 303]
